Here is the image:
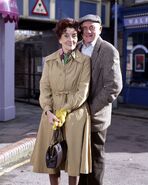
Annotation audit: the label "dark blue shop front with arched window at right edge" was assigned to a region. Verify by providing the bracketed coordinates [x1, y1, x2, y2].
[123, 5, 148, 107]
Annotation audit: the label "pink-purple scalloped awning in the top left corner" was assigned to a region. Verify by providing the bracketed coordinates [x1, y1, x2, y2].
[0, 0, 19, 22]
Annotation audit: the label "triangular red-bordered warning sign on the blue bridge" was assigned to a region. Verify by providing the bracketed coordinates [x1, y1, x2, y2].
[32, 0, 48, 16]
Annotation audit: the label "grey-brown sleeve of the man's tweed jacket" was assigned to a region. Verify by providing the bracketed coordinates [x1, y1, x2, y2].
[90, 48, 122, 113]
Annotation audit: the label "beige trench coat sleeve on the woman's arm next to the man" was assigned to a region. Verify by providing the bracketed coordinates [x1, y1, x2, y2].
[63, 57, 90, 112]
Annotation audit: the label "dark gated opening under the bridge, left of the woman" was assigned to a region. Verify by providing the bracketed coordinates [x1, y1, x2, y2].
[15, 31, 58, 104]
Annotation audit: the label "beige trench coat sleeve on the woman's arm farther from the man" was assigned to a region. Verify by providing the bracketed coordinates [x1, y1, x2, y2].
[39, 59, 52, 112]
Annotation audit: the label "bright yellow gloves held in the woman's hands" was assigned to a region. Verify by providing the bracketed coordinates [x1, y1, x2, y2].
[52, 109, 67, 130]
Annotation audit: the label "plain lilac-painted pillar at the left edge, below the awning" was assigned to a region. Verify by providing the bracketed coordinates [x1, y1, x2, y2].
[0, 17, 15, 121]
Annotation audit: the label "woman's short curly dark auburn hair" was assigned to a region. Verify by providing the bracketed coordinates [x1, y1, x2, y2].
[54, 18, 79, 39]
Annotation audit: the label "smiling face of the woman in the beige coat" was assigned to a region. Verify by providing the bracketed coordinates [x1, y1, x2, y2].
[59, 28, 78, 53]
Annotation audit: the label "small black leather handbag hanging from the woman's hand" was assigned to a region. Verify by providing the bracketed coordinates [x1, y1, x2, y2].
[46, 128, 67, 168]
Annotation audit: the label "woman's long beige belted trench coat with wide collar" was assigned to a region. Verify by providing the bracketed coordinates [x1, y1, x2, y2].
[31, 50, 91, 176]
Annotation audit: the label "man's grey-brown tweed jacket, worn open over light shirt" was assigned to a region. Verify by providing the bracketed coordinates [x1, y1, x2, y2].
[79, 37, 122, 132]
